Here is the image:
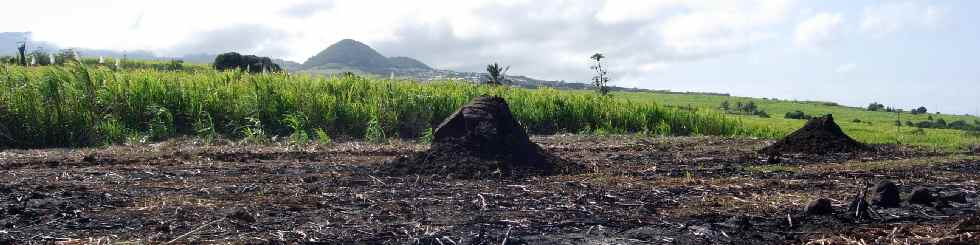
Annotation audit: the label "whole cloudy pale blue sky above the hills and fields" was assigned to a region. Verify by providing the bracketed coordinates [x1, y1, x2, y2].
[0, 0, 980, 115]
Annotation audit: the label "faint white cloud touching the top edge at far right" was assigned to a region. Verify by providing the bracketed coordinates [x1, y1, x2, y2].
[860, 2, 949, 37]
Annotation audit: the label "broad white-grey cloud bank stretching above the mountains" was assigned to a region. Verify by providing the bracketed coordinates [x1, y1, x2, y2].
[0, 0, 797, 83]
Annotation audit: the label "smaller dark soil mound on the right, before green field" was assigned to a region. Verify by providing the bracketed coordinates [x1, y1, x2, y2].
[762, 114, 868, 154]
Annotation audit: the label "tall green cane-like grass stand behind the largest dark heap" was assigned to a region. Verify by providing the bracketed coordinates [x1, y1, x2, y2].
[0, 63, 748, 148]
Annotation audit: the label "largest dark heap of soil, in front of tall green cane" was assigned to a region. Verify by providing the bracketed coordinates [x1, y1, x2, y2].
[381, 96, 584, 179]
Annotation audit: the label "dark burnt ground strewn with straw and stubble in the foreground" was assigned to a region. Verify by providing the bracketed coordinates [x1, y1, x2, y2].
[0, 135, 980, 244]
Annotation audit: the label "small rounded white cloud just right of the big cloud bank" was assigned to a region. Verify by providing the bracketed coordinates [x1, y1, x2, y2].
[793, 13, 844, 47]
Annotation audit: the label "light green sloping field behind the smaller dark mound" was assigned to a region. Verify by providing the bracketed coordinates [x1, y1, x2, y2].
[614, 93, 980, 150]
